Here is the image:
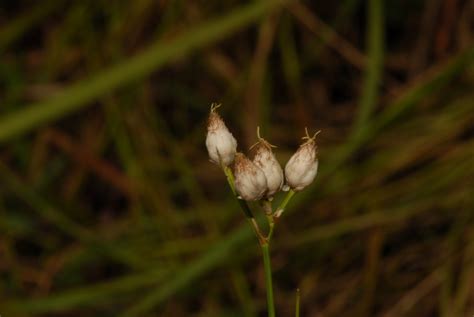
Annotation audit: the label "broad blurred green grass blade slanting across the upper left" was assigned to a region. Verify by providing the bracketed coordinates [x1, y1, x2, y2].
[0, 1, 284, 142]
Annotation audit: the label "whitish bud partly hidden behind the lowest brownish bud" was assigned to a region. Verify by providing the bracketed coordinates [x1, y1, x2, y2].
[253, 130, 283, 198]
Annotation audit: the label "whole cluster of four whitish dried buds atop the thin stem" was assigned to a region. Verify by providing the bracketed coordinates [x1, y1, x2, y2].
[206, 104, 319, 201]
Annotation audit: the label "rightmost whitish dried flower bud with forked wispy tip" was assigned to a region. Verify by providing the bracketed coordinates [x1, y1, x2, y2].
[285, 130, 319, 191]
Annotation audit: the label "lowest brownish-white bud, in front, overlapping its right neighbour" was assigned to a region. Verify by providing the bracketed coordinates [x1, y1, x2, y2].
[234, 153, 267, 200]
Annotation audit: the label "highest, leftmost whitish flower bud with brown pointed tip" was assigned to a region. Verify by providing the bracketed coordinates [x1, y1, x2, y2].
[206, 104, 237, 166]
